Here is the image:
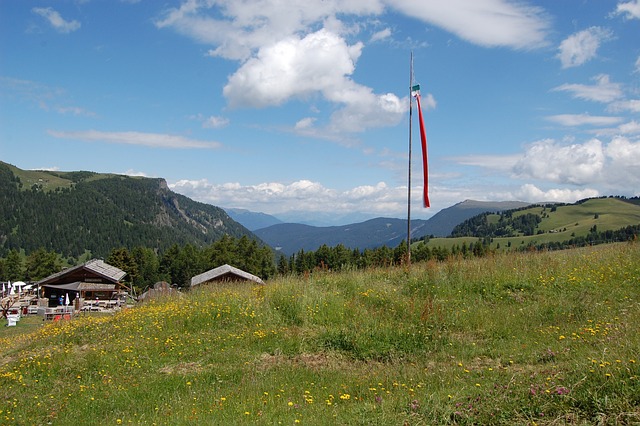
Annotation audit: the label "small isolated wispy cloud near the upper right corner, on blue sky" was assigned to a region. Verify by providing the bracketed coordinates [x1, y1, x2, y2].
[558, 27, 613, 68]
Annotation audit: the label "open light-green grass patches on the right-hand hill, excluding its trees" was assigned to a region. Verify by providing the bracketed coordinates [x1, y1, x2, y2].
[428, 198, 640, 250]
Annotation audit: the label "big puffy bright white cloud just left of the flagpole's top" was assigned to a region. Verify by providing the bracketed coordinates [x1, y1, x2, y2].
[223, 29, 407, 132]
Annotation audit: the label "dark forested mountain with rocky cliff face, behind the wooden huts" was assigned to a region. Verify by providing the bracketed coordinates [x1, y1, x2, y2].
[0, 162, 255, 258]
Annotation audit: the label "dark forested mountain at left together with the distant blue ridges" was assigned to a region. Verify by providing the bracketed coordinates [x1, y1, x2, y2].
[6, 162, 636, 257]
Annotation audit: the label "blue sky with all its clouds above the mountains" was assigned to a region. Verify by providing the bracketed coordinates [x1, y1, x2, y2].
[0, 0, 640, 224]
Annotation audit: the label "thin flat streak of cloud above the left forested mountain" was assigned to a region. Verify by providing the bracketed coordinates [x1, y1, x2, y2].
[47, 130, 222, 149]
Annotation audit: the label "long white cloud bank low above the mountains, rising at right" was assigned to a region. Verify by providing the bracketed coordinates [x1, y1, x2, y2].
[169, 137, 640, 217]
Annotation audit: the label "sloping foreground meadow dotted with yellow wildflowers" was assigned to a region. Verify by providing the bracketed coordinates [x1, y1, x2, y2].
[0, 243, 640, 425]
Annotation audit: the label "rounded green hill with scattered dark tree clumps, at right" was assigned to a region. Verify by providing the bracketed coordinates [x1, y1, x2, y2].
[427, 197, 640, 250]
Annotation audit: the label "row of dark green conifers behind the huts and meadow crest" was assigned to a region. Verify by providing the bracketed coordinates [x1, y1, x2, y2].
[0, 225, 640, 292]
